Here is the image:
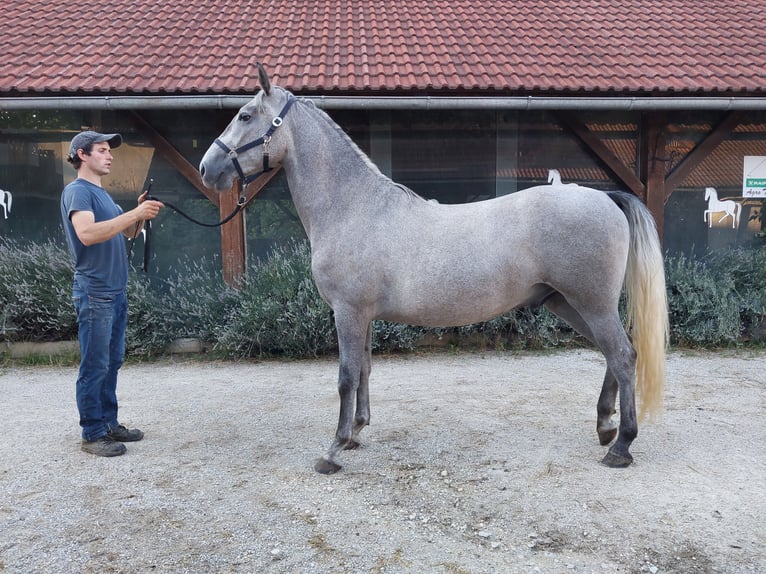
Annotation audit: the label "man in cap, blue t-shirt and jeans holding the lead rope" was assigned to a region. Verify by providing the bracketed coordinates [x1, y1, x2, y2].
[61, 131, 163, 456]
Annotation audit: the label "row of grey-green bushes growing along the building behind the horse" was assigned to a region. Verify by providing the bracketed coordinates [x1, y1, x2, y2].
[0, 238, 766, 358]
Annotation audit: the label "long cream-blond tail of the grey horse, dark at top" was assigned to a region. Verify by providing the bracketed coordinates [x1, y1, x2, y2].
[609, 192, 670, 418]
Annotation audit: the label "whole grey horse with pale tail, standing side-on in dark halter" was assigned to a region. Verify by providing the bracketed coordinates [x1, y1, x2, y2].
[199, 65, 668, 474]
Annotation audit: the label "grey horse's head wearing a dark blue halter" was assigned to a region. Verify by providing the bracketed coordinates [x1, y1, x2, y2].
[199, 64, 295, 192]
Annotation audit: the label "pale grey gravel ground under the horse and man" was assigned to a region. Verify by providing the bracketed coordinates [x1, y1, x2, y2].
[0, 350, 766, 574]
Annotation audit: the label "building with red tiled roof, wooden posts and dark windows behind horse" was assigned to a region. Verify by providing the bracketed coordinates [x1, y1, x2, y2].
[0, 0, 766, 280]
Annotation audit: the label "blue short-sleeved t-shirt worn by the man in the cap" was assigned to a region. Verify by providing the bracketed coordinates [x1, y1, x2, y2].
[61, 178, 128, 295]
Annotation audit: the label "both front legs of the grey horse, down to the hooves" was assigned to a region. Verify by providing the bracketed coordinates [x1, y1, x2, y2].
[314, 316, 370, 474]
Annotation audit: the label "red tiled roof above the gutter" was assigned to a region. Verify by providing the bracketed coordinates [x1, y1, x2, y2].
[0, 0, 766, 96]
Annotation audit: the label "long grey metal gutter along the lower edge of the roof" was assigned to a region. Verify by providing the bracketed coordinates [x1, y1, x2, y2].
[0, 95, 766, 111]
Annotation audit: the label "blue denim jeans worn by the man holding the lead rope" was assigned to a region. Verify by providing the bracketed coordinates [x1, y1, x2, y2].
[72, 287, 128, 441]
